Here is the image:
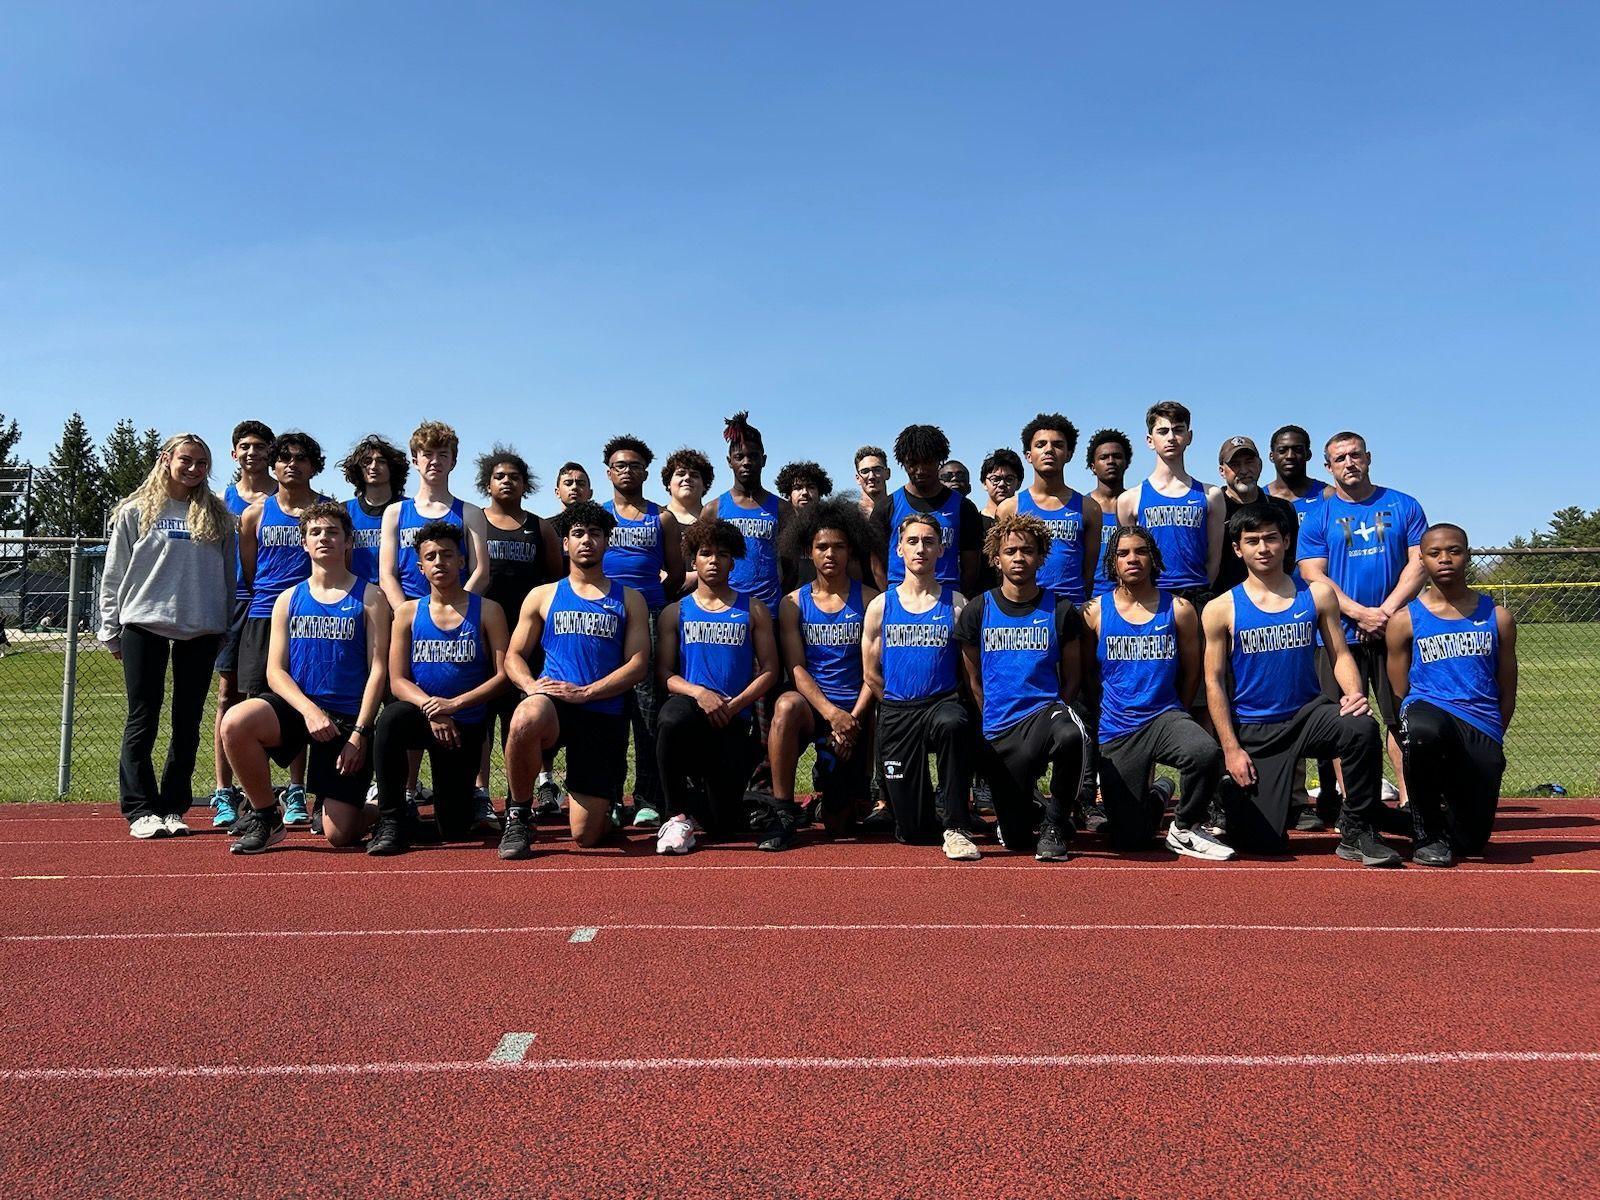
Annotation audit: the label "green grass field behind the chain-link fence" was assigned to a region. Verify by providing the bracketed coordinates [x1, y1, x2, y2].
[0, 624, 1600, 803]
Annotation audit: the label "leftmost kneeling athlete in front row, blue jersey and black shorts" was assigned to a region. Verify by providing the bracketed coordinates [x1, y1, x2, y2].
[222, 501, 389, 854]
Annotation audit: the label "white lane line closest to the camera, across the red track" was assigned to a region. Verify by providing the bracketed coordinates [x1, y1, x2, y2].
[0, 1050, 1600, 1083]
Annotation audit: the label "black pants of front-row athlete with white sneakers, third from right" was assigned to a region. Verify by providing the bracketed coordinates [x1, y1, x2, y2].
[1099, 709, 1222, 850]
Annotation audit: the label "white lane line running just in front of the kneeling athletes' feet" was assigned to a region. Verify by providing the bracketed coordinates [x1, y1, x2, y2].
[0, 854, 1600, 883]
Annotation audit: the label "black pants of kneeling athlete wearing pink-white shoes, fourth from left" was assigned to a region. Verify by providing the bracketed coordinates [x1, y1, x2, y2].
[656, 696, 762, 835]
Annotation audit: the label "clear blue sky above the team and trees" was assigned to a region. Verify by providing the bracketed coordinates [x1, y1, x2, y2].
[0, 0, 1600, 544]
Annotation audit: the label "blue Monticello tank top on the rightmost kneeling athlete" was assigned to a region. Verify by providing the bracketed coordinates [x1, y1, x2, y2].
[1402, 594, 1506, 741]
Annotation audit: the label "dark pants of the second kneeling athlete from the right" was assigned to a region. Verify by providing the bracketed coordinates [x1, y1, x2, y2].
[1221, 696, 1384, 854]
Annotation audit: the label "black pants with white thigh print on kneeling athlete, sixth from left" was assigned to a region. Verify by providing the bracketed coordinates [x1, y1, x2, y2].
[878, 693, 978, 845]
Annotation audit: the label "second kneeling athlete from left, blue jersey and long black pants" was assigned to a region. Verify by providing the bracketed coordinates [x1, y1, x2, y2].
[366, 520, 506, 854]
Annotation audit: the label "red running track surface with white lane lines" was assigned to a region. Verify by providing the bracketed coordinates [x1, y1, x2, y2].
[0, 798, 1600, 1197]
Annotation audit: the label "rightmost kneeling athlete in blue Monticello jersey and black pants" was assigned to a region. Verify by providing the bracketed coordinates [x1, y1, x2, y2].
[1384, 525, 1517, 867]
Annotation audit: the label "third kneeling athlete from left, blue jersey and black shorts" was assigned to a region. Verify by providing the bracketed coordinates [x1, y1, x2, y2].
[499, 501, 650, 859]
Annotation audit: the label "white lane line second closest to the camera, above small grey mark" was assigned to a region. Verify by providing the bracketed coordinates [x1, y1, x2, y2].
[0, 922, 1600, 944]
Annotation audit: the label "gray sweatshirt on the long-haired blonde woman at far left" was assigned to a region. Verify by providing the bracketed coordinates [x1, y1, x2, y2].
[99, 501, 238, 650]
